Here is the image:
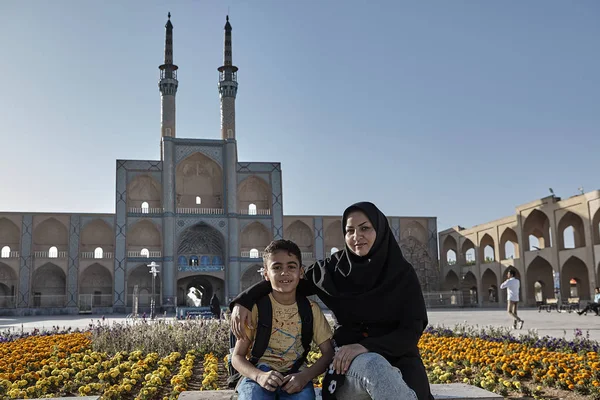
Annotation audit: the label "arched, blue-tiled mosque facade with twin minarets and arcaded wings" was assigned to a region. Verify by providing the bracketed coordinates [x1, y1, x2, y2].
[0, 14, 438, 315]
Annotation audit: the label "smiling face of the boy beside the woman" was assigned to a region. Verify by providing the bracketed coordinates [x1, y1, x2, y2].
[264, 250, 302, 293]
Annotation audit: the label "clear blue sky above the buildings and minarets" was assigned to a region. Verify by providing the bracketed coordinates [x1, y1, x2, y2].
[0, 0, 600, 230]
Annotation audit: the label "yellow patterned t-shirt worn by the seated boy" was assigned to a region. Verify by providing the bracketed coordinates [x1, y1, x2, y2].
[246, 294, 333, 373]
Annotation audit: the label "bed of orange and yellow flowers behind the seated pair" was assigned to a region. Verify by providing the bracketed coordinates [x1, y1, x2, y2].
[0, 321, 600, 400]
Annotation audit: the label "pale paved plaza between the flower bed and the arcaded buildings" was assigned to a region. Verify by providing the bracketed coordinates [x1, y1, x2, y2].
[0, 309, 600, 341]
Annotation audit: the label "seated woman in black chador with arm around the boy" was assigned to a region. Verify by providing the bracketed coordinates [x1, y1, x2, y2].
[231, 202, 433, 400]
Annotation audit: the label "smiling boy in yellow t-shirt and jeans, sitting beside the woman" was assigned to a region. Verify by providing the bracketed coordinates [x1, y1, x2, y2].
[231, 240, 334, 400]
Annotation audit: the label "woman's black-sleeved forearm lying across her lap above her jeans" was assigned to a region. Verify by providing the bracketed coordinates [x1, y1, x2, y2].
[360, 320, 425, 358]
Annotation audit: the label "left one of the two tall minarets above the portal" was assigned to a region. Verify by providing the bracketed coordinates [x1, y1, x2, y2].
[158, 13, 179, 156]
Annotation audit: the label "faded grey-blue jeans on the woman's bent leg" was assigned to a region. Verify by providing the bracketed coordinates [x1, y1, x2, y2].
[336, 353, 417, 400]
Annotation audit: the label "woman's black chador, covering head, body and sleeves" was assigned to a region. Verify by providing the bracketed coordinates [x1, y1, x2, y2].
[230, 202, 433, 400]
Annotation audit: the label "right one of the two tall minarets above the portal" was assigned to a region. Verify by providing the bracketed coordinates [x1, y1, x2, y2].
[218, 15, 237, 140]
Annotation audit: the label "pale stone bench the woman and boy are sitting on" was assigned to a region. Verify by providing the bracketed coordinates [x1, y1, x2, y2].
[179, 383, 503, 400]
